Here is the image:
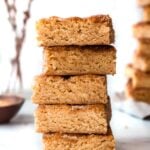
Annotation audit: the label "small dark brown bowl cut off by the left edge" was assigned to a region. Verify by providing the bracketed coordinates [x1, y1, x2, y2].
[0, 95, 25, 123]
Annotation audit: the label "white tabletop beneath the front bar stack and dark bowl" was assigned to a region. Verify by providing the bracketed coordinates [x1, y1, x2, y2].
[0, 101, 150, 150]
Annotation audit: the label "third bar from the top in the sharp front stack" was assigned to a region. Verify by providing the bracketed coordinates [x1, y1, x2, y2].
[32, 75, 108, 104]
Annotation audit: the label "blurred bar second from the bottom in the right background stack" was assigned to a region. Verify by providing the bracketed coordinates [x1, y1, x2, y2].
[125, 64, 150, 88]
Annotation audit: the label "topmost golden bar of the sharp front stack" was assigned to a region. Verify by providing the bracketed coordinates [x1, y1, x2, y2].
[36, 15, 114, 46]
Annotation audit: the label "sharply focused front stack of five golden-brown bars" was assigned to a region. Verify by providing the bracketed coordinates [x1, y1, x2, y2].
[32, 15, 116, 150]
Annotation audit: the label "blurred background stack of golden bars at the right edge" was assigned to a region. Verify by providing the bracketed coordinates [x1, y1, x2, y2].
[125, 0, 150, 103]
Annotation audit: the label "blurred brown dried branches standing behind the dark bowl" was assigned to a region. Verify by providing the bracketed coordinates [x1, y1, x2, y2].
[5, 0, 33, 92]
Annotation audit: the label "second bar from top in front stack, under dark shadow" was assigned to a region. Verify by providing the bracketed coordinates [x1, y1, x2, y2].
[43, 46, 116, 75]
